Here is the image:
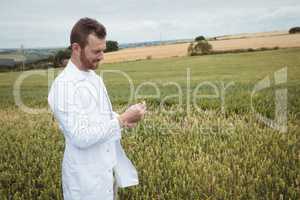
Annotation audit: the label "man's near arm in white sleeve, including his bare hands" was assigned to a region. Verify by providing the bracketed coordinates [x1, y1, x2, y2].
[48, 80, 146, 148]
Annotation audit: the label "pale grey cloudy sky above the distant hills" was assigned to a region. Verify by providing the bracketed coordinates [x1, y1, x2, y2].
[0, 0, 300, 48]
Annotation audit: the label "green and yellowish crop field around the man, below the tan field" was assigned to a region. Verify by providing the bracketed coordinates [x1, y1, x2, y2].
[0, 48, 300, 200]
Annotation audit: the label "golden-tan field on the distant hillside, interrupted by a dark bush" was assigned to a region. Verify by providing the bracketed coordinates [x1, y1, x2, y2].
[104, 32, 300, 63]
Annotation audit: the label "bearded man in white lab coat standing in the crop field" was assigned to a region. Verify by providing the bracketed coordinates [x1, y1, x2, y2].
[48, 18, 146, 200]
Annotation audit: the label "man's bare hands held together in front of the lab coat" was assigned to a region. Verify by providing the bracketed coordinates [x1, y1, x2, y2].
[119, 103, 147, 128]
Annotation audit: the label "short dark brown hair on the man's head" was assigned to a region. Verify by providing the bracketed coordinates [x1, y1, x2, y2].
[70, 17, 106, 48]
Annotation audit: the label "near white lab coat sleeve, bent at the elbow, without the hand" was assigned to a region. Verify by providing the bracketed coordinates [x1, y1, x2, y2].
[48, 81, 121, 148]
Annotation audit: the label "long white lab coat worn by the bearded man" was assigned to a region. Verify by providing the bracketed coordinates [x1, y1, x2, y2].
[48, 60, 138, 200]
